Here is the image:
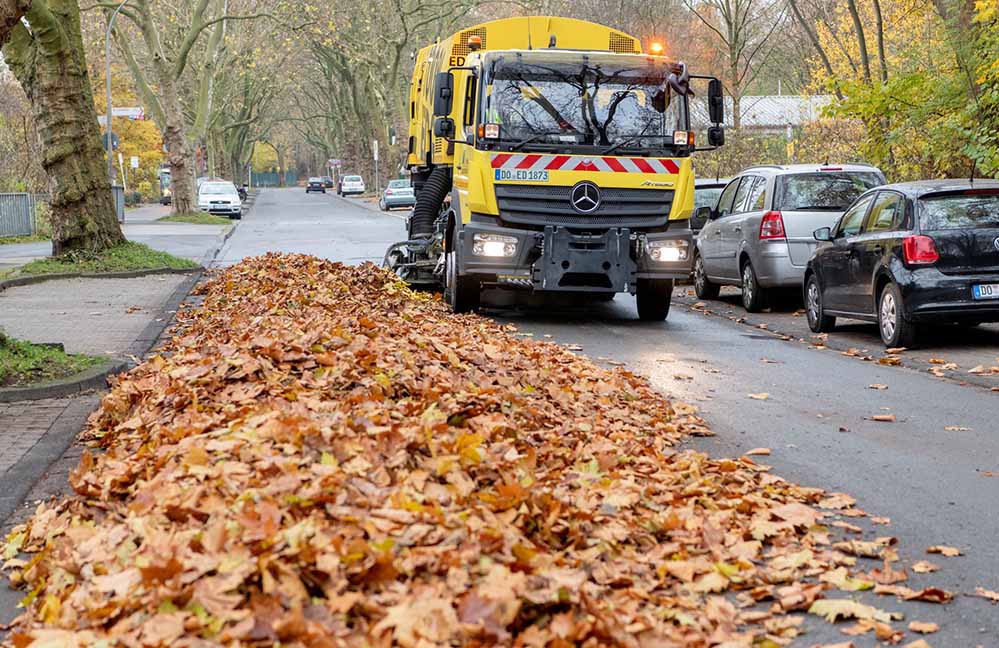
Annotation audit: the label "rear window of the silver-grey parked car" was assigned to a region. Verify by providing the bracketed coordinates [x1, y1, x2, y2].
[774, 171, 884, 211]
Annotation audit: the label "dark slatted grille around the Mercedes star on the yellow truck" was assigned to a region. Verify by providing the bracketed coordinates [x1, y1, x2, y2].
[496, 185, 673, 227]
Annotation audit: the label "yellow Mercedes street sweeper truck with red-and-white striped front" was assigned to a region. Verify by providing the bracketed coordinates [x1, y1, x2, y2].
[392, 18, 722, 320]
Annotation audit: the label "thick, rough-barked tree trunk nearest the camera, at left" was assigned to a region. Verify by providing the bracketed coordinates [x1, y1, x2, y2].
[4, 0, 125, 255]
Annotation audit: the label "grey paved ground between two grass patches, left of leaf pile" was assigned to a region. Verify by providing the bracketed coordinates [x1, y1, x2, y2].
[0, 275, 188, 356]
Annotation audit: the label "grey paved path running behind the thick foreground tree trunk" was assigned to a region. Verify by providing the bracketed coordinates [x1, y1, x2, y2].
[0, 205, 231, 270]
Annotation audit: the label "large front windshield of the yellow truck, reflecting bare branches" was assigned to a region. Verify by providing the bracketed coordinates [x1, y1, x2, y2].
[480, 55, 687, 149]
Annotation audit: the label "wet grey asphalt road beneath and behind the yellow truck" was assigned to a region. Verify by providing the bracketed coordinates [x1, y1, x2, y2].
[217, 189, 999, 648]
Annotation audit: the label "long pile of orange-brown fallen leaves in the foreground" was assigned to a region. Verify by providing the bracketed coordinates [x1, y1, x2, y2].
[5, 255, 936, 647]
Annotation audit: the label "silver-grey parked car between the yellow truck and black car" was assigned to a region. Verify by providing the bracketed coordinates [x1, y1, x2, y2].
[694, 164, 885, 312]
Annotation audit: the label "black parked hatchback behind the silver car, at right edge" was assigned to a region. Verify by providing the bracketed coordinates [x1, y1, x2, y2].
[804, 180, 999, 347]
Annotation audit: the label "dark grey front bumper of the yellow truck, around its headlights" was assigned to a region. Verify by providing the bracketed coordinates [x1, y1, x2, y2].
[458, 222, 693, 294]
